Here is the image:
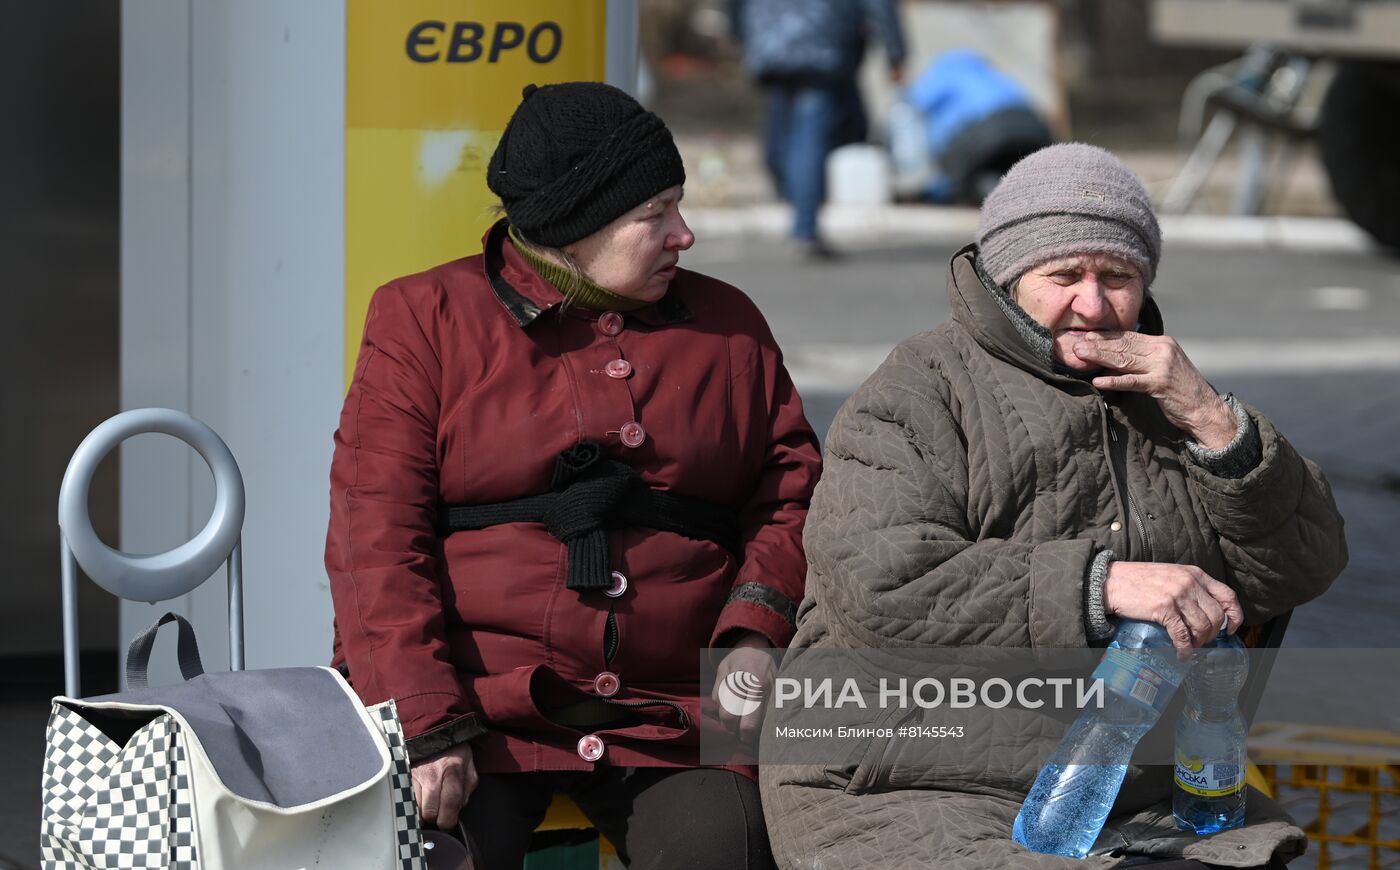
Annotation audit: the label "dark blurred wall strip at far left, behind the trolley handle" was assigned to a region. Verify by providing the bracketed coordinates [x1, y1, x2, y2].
[0, 0, 120, 688]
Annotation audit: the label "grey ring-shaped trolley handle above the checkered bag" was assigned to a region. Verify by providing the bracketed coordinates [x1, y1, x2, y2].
[59, 408, 246, 698]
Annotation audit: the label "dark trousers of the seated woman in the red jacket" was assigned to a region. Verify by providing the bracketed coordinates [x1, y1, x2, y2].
[462, 768, 773, 870]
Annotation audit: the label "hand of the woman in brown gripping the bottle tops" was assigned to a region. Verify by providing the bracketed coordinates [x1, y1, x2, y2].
[1103, 562, 1245, 650]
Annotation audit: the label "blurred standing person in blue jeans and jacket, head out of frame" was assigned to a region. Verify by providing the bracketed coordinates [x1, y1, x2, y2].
[729, 0, 904, 258]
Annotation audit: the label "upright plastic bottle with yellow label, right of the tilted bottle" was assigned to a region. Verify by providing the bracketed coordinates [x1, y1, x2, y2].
[1172, 632, 1249, 834]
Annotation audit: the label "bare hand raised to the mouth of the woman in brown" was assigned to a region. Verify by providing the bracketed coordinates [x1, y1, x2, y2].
[1074, 331, 1238, 450]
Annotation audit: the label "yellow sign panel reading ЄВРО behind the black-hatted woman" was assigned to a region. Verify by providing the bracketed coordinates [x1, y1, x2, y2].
[346, 0, 608, 382]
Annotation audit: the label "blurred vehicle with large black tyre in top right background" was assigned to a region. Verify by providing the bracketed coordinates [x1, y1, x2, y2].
[1152, 0, 1400, 248]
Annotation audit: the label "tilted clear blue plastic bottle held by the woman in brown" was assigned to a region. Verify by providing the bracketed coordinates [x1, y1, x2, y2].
[1011, 619, 1190, 857]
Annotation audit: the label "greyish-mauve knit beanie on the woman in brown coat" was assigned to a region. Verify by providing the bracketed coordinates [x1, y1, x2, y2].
[977, 143, 1162, 287]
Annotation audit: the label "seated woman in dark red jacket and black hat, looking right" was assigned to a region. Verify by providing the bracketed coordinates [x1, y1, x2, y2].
[326, 83, 819, 869]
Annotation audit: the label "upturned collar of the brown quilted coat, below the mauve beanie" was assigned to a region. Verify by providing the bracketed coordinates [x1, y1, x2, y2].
[948, 245, 1162, 387]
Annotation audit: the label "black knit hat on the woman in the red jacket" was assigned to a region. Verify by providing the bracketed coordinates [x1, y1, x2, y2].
[486, 81, 686, 248]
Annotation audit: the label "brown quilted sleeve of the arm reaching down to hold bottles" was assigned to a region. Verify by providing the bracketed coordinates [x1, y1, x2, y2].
[804, 345, 1098, 647]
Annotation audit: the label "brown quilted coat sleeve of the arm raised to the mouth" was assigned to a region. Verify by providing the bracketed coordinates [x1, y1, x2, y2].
[1186, 405, 1347, 623]
